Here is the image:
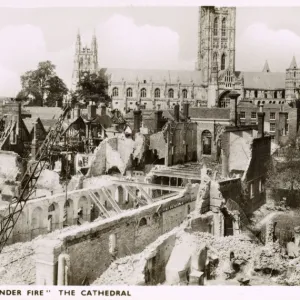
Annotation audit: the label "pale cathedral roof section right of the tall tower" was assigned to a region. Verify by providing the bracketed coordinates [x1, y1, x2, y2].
[243, 72, 285, 90]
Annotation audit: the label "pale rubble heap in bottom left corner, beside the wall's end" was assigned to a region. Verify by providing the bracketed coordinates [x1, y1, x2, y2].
[0, 242, 35, 285]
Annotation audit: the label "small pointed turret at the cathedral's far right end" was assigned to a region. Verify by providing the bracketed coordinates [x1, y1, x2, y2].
[285, 56, 300, 101]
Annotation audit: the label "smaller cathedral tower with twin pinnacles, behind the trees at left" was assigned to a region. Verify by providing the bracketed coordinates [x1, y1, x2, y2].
[72, 32, 98, 90]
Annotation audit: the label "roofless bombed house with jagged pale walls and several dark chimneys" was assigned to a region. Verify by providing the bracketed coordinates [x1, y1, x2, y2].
[89, 103, 197, 176]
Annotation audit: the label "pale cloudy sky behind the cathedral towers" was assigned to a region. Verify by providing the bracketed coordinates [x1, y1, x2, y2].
[0, 7, 300, 96]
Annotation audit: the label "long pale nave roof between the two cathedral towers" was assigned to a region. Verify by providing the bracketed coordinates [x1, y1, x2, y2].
[106, 68, 202, 85]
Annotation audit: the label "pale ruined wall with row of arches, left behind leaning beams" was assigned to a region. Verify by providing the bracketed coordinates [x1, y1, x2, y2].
[0, 176, 137, 243]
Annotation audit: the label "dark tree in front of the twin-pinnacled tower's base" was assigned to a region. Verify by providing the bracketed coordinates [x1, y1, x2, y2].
[76, 69, 110, 103]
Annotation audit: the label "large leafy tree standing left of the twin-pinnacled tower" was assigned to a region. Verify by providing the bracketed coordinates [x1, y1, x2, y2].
[19, 60, 68, 106]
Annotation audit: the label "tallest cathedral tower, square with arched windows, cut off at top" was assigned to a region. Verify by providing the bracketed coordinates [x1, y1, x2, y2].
[197, 6, 236, 85]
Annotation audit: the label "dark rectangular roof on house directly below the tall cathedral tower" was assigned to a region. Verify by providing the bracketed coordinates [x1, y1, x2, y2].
[189, 107, 230, 120]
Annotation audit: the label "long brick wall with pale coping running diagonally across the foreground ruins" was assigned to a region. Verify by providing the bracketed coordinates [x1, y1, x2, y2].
[36, 185, 198, 285]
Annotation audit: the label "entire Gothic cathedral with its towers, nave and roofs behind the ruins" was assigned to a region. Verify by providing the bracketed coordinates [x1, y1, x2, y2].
[72, 6, 300, 112]
